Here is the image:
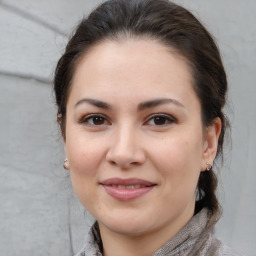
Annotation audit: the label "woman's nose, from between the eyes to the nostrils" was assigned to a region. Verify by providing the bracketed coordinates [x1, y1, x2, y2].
[106, 126, 146, 169]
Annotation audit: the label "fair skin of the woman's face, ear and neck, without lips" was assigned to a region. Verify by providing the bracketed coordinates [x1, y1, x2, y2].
[65, 39, 221, 256]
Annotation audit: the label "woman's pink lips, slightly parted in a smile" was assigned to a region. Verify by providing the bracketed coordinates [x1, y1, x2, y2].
[100, 178, 156, 201]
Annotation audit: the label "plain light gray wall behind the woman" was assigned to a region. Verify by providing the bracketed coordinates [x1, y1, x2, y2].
[0, 0, 256, 256]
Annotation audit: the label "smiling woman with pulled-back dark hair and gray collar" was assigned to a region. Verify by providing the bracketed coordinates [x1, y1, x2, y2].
[54, 0, 240, 256]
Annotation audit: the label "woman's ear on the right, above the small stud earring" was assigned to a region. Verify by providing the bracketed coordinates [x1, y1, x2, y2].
[201, 117, 222, 171]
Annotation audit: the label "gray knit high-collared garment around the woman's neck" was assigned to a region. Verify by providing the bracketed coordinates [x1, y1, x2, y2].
[76, 209, 241, 256]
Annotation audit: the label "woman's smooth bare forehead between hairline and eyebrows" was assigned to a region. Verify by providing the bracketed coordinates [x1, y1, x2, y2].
[71, 39, 198, 108]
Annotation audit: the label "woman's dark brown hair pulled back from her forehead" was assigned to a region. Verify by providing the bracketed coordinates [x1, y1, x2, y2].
[54, 0, 228, 219]
